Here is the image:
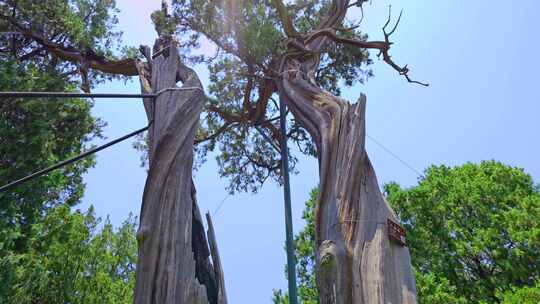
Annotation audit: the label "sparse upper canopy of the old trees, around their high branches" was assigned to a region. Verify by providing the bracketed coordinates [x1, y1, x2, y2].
[0, 0, 372, 192]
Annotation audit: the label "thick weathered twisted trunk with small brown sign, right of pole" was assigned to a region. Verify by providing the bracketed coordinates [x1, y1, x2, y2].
[279, 72, 416, 304]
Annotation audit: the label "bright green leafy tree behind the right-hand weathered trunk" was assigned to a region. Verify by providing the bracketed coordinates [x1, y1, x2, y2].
[273, 161, 540, 304]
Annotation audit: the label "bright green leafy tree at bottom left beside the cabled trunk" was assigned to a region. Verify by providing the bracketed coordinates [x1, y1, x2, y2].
[0, 205, 137, 304]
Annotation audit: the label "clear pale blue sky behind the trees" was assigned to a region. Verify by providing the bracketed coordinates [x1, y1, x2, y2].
[81, 0, 540, 303]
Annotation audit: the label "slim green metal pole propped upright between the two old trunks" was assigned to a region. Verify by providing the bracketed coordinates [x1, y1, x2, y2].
[279, 98, 298, 304]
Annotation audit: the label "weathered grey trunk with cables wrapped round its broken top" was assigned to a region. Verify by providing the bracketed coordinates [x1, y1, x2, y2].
[134, 39, 226, 304]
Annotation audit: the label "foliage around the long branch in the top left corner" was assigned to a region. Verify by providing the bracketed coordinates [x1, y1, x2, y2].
[0, 0, 133, 86]
